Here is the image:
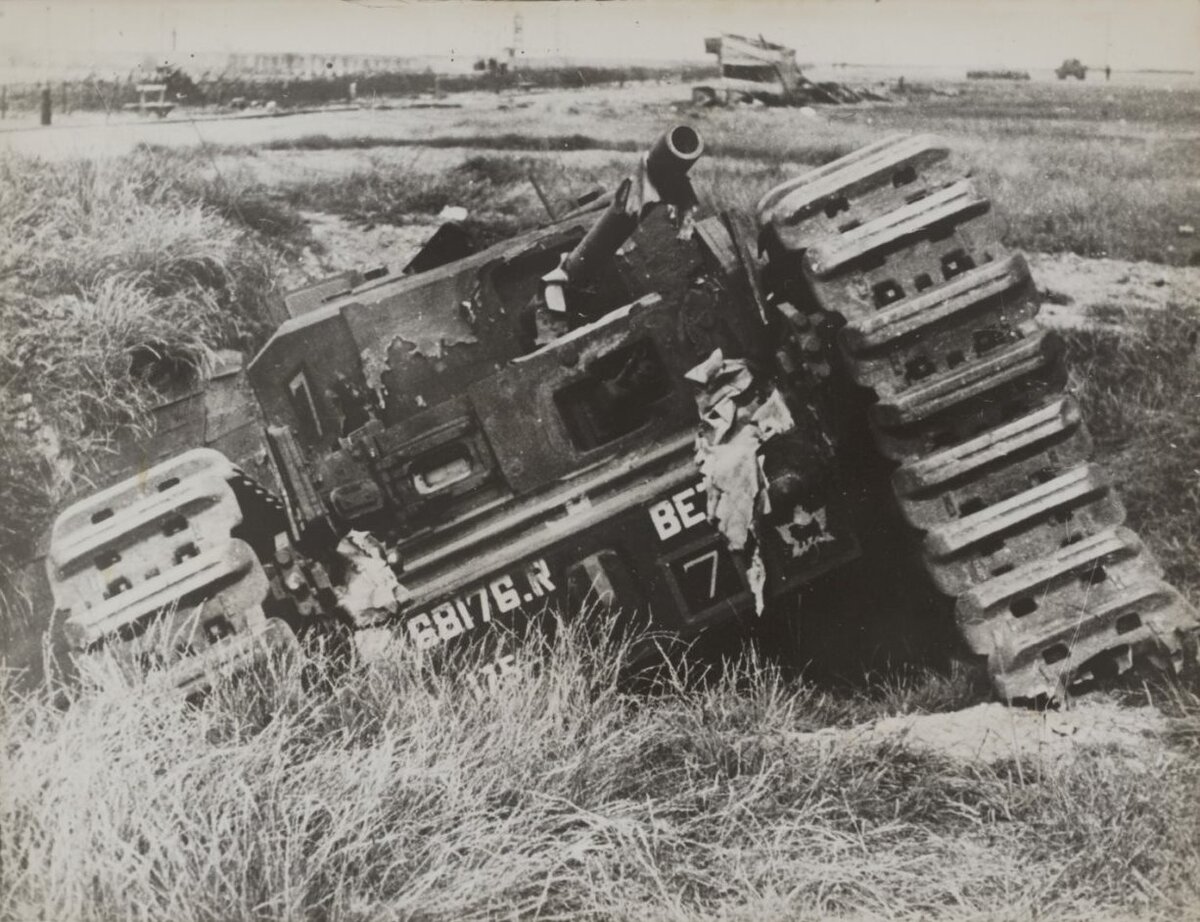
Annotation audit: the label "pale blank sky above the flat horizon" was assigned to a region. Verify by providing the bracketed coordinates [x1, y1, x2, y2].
[0, 0, 1200, 71]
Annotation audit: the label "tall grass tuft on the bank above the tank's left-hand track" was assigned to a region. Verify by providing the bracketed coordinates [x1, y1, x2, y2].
[0, 150, 290, 605]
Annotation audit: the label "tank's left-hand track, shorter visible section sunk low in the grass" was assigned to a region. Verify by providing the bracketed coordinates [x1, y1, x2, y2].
[47, 448, 321, 694]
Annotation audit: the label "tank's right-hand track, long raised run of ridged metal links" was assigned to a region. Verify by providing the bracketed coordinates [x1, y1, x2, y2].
[757, 136, 1200, 700]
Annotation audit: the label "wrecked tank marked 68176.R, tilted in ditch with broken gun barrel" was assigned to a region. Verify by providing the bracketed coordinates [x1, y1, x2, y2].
[48, 126, 1198, 699]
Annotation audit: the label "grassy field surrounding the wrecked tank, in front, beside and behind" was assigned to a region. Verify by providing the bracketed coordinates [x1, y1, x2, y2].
[0, 75, 1200, 922]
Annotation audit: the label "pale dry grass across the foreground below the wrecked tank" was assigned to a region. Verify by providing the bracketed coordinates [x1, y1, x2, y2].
[0, 619, 1200, 922]
